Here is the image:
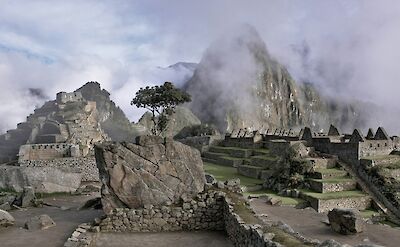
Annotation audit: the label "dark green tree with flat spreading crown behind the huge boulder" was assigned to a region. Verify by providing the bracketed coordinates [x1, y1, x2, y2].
[131, 82, 191, 135]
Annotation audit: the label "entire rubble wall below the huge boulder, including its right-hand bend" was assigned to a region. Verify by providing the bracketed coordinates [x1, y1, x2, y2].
[100, 190, 304, 247]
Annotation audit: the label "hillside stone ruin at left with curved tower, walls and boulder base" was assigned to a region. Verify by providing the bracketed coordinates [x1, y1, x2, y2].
[0, 87, 110, 193]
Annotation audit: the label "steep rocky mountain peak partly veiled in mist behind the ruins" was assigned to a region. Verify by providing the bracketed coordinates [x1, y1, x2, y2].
[184, 26, 361, 131]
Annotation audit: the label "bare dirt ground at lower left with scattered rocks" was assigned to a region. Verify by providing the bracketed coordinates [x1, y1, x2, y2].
[0, 196, 103, 247]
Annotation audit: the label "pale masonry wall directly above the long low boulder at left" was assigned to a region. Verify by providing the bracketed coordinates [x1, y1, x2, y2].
[19, 157, 99, 182]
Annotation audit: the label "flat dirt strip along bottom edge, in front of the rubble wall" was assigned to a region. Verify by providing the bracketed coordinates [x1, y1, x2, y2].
[94, 232, 233, 247]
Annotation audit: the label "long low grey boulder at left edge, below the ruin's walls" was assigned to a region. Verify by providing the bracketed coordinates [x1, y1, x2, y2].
[0, 165, 82, 193]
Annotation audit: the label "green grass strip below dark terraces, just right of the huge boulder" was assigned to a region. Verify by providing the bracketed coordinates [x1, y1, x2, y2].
[203, 162, 263, 186]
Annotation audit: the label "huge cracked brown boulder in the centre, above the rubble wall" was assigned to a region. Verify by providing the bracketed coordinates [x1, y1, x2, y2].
[95, 136, 205, 213]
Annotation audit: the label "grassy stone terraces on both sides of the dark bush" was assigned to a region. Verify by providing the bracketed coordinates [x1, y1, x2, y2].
[202, 142, 377, 216]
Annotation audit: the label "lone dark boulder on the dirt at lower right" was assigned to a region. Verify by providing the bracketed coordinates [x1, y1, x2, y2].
[328, 208, 366, 235]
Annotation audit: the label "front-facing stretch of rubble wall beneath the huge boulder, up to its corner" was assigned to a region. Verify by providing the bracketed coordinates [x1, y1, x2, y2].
[100, 191, 224, 232]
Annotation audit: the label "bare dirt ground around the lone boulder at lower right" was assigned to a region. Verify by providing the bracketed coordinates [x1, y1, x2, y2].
[251, 199, 400, 247]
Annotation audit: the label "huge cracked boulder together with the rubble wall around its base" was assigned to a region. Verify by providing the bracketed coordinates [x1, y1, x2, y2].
[94, 136, 307, 247]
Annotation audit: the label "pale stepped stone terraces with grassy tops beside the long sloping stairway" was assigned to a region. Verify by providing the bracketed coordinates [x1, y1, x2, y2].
[300, 158, 372, 212]
